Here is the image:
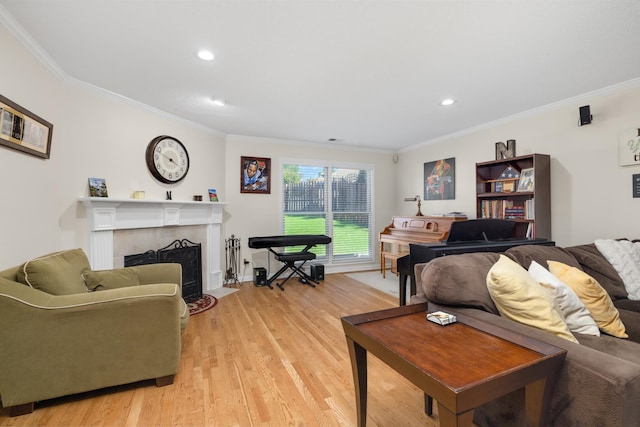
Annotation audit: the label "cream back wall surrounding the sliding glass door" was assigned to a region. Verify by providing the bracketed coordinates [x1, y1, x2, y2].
[225, 135, 401, 274]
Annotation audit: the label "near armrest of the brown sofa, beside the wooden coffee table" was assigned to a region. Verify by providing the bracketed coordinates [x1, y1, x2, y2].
[429, 303, 640, 426]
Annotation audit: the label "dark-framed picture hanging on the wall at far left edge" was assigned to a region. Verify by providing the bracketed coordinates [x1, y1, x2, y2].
[0, 95, 53, 159]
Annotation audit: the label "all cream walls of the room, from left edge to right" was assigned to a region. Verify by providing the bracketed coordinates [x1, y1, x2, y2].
[0, 16, 640, 269]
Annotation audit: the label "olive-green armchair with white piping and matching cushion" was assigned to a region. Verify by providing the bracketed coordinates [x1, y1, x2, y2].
[0, 249, 189, 416]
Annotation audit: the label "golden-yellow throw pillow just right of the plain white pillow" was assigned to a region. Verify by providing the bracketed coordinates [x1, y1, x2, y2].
[547, 261, 629, 338]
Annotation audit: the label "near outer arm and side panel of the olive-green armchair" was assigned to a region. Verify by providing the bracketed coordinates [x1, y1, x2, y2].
[0, 280, 181, 407]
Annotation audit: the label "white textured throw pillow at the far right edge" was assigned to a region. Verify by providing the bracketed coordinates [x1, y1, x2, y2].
[594, 239, 640, 301]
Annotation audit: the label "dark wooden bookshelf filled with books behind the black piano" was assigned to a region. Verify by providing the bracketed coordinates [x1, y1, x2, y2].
[476, 154, 551, 239]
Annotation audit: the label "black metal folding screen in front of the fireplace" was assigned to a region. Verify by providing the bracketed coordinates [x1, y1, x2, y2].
[124, 239, 202, 302]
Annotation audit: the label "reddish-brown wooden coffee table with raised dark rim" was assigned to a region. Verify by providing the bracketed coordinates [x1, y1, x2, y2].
[342, 303, 566, 427]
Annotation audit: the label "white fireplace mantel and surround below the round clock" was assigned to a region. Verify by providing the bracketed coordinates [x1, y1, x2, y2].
[79, 197, 226, 292]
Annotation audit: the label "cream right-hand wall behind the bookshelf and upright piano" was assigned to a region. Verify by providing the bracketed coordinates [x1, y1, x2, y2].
[397, 81, 640, 246]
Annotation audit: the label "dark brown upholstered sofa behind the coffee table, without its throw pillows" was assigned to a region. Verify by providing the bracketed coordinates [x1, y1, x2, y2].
[411, 244, 640, 427]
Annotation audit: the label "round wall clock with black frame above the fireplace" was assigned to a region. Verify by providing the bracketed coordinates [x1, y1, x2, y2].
[146, 135, 189, 184]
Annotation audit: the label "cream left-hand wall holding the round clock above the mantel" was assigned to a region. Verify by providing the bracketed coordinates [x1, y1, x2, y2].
[0, 26, 225, 269]
